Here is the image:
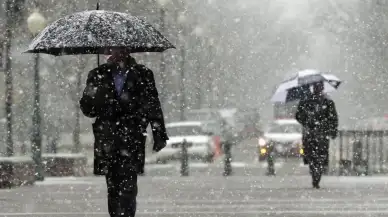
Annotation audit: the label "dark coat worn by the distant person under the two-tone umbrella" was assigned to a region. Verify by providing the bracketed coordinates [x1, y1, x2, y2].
[295, 95, 338, 165]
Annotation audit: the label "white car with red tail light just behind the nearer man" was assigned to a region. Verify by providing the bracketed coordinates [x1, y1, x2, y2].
[156, 121, 221, 163]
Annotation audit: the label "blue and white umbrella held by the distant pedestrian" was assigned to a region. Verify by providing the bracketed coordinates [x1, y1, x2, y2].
[271, 69, 342, 103]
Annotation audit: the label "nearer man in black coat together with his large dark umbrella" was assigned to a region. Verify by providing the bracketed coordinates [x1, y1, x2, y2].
[26, 6, 175, 217]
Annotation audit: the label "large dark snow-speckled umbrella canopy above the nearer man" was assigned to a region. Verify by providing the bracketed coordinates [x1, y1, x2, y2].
[26, 10, 175, 56]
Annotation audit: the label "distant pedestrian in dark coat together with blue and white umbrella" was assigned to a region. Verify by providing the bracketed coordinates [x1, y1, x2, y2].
[271, 69, 342, 188]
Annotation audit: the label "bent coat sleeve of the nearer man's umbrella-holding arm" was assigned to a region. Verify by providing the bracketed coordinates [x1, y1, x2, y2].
[80, 69, 104, 118]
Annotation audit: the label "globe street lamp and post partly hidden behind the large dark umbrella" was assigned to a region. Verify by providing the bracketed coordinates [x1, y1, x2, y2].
[27, 11, 46, 181]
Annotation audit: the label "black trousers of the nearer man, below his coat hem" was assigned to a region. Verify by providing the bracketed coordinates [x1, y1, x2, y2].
[106, 156, 138, 217]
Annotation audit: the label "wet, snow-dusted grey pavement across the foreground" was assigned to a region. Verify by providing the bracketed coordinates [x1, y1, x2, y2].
[0, 176, 388, 217]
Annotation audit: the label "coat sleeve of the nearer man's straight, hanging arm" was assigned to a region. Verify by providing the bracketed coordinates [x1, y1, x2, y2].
[142, 66, 168, 141]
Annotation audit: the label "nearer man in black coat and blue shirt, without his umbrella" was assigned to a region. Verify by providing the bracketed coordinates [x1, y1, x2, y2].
[80, 48, 168, 217]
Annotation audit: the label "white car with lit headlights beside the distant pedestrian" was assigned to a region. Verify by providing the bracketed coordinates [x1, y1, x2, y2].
[258, 119, 303, 161]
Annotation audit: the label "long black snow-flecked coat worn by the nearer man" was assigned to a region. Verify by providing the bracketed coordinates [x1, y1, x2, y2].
[80, 58, 168, 175]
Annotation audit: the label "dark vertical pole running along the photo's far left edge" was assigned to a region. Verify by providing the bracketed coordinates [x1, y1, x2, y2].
[3, 0, 15, 157]
